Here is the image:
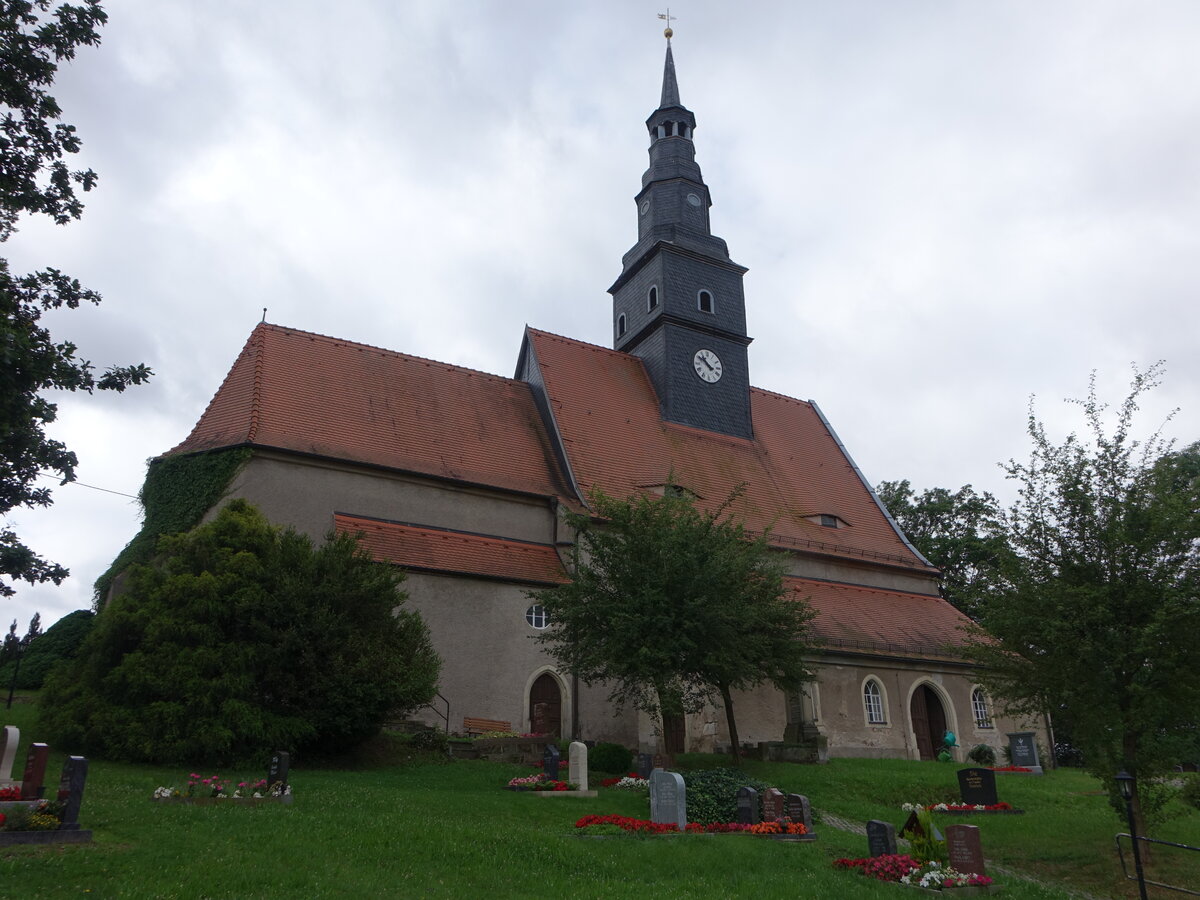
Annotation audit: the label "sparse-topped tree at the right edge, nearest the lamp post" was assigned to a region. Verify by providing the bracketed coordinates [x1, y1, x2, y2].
[973, 365, 1200, 826]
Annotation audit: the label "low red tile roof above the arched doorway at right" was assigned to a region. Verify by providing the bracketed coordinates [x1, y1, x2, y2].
[785, 578, 972, 655]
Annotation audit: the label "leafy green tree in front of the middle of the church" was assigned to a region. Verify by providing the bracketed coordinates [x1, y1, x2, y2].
[530, 485, 812, 762]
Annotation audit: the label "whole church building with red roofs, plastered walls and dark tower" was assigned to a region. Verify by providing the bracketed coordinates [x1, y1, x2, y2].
[138, 35, 1044, 760]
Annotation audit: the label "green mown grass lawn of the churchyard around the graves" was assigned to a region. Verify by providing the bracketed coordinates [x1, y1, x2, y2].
[0, 706, 1200, 900]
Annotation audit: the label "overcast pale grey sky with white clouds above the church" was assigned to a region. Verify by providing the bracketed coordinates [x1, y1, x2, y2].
[0, 0, 1200, 631]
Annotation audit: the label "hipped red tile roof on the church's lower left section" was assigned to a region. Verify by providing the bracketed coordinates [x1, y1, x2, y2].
[170, 323, 569, 496]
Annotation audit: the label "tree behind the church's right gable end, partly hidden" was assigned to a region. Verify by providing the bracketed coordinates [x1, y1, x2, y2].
[875, 481, 1006, 620]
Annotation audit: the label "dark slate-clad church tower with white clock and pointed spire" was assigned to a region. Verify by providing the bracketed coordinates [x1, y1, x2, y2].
[608, 29, 754, 438]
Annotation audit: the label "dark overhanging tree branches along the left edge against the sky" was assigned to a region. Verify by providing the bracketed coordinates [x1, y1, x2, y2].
[0, 0, 151, 596]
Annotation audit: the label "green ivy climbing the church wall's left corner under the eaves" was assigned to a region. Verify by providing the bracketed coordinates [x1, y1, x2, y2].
[95, 446, 253, 610]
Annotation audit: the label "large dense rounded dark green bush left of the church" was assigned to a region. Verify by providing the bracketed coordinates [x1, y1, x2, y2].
[41, 500, 440, 764]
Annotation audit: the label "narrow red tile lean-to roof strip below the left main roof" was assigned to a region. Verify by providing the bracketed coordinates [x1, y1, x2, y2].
[334, 514, 566, 584]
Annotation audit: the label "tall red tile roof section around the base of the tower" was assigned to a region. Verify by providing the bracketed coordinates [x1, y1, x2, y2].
[526, 329, 929, 569]
